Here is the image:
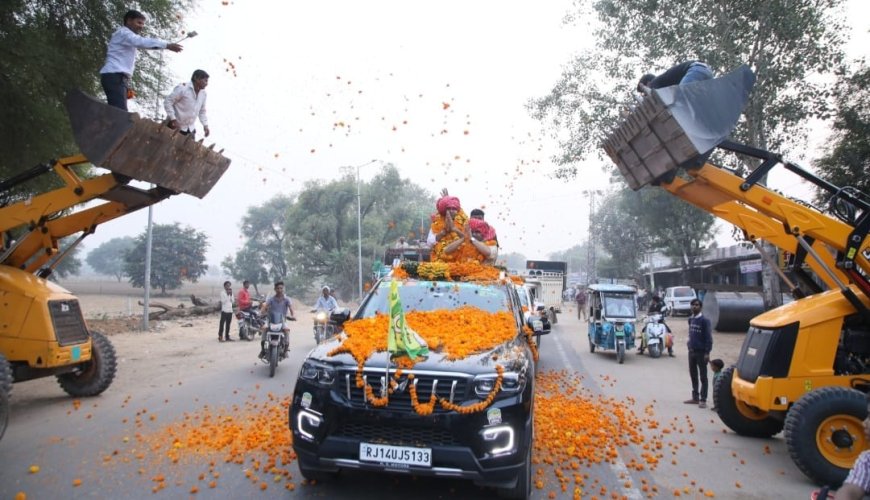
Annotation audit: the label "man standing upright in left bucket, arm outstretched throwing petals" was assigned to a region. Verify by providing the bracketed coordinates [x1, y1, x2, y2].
[100, 10, 182, 111]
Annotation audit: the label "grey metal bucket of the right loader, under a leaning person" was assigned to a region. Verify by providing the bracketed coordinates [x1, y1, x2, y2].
[602, 65, 755, 191]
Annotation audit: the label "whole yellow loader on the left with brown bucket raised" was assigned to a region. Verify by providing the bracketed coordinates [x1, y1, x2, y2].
[0, 91, 229, 442]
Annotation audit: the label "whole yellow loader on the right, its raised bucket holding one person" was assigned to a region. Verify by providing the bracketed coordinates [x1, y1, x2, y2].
[603, 66, 870, 486]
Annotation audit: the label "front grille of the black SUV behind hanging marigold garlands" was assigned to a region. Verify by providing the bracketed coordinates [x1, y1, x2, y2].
[340, 370, 469, 413]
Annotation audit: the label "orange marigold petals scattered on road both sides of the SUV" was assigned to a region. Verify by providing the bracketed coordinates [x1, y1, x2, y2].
[49, 371, 728, 499]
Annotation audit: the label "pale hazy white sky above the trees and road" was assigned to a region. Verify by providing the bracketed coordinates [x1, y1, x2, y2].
[84, 0, 870, 270]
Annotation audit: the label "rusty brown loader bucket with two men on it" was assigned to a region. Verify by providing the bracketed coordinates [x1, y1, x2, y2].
[66, 90, 230, 198]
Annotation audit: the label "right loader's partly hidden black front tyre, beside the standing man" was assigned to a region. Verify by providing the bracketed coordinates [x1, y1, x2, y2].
[713, 366, 784, 438]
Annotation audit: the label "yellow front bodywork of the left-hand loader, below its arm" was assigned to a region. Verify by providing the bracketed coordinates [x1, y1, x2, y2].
[0, 266, 91, 368]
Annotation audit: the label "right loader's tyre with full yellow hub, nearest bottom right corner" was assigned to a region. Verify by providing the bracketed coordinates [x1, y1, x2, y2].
[785, 387, 868, 488]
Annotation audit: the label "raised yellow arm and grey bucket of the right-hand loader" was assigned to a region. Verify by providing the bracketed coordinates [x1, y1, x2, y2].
[603, 66, 870, 315]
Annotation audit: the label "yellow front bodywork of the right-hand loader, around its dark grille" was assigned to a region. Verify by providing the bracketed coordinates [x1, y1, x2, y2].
[731, 285, 870, 411]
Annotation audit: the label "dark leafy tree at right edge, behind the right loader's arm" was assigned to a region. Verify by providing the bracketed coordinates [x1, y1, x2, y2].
[814, 61, 870, 204]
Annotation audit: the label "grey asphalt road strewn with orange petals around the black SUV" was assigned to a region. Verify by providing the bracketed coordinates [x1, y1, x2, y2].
[0, 311, 813, 499]
